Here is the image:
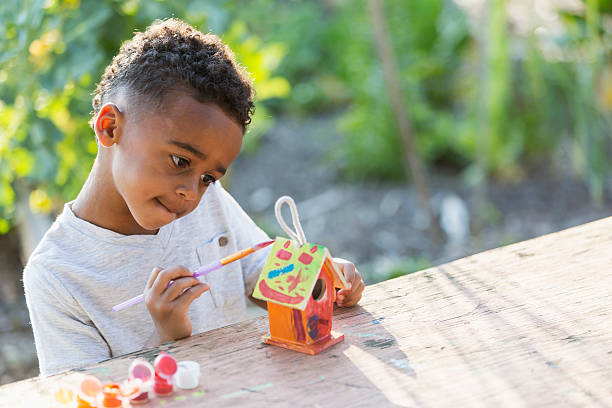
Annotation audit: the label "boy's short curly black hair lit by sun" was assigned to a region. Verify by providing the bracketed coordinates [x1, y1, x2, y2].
[90, 18, 255, 131]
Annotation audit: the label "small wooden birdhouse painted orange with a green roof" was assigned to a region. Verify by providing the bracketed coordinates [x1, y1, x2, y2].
[253, 237, 348, 354]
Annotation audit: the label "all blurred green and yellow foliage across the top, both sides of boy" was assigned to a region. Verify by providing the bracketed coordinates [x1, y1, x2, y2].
[0, 0, 612, 236]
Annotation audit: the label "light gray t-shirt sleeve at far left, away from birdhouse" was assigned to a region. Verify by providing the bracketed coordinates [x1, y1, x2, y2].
[23, 263, 111, 375]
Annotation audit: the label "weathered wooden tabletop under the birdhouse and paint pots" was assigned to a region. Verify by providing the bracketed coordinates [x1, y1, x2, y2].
[0, 218, 612, 407]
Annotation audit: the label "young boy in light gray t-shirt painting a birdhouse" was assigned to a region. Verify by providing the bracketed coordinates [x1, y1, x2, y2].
[24, 19, 363, 375]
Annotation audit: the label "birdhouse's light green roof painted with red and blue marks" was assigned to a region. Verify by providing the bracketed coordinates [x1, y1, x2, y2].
[253, 237, 348, 310]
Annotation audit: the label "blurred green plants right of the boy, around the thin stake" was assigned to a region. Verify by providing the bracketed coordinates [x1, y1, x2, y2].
[228, 0, 612, 199]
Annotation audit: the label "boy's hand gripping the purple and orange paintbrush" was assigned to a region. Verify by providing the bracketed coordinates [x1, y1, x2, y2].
[144, 266, 210, 343]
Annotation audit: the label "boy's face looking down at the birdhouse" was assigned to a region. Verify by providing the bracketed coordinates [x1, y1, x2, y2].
[102, 94, 243, 232]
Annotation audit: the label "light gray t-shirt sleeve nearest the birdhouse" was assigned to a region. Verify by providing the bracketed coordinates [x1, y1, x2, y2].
[217, 185, 270, 296]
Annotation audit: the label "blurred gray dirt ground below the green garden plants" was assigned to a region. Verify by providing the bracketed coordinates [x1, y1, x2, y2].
[0, 118, 612, 384]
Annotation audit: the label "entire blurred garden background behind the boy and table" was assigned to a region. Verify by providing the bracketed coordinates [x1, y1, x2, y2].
[0, 0, 612, 383]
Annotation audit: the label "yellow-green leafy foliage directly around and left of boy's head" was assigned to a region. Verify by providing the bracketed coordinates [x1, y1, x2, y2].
[0, 0, 290, 233]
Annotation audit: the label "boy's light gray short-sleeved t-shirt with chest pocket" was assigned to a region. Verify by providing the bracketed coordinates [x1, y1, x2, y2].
[23, 183, 269, 375]
